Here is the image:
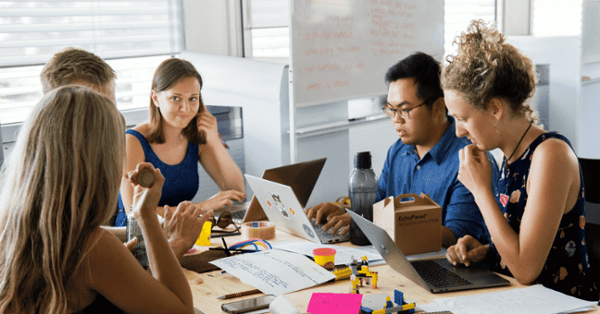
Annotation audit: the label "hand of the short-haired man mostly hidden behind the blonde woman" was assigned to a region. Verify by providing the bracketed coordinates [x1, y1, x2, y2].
[163, 201, 213, 253]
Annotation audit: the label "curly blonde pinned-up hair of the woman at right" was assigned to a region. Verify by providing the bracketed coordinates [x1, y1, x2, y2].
[441, 20, 537, 121]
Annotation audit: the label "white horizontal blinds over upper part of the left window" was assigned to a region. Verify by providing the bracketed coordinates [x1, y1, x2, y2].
[0, 0, 184, 67]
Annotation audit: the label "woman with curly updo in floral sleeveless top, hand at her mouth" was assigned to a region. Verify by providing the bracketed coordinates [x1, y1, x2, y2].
[441, 21, 598, 300]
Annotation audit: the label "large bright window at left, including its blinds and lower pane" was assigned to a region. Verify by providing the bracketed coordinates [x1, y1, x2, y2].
[0, 0, 183, 125]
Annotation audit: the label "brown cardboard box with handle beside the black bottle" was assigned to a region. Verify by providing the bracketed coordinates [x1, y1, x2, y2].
[373, 193, 442, 255]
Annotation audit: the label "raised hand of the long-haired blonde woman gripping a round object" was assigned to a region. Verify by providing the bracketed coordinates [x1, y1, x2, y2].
[125, 162, 165, 219]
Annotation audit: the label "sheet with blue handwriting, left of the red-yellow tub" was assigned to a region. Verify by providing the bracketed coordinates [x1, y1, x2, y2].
[211, 250, 335, 295]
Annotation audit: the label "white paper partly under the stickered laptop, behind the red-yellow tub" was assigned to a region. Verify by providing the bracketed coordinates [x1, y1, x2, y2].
[272, 241, 383, 265]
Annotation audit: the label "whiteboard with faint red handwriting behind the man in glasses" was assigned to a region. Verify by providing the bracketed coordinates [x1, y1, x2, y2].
[290, 0, 444, 107]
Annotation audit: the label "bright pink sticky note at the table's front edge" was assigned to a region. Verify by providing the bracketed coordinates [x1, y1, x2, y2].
[308, 293, 362, 314]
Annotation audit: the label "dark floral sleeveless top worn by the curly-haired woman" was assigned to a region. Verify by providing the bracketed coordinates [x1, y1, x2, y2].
[488, 132, 598, 301]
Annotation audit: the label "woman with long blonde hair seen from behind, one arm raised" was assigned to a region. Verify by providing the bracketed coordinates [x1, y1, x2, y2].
[0, 85, 204, 313]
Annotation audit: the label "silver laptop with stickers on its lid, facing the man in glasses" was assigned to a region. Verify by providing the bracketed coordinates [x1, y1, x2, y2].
[245, 174, 350, 243]
